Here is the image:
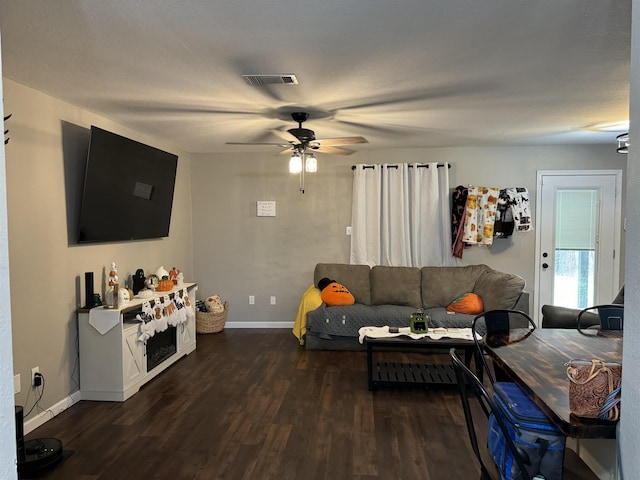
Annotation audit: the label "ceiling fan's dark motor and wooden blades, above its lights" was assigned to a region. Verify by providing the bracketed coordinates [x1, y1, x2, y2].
[226, 112, 369, 155]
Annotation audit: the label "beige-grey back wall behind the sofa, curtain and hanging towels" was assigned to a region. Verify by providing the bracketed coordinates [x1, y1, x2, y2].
[192, 141, 626, 322]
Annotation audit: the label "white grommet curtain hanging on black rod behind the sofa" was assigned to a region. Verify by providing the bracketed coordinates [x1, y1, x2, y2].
[350, 163, 455, 267]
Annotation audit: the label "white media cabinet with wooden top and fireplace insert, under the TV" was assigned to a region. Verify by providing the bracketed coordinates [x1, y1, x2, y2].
[78, 283, 197, 401]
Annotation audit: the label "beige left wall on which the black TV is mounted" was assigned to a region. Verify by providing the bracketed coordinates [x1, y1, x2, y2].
[3, 79, 193, 429]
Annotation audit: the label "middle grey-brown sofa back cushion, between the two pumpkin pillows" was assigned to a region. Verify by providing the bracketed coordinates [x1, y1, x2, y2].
[371, 265, 422, 308]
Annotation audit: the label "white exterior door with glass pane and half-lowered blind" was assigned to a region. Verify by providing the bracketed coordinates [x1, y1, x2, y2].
[534, 170, 622, 320]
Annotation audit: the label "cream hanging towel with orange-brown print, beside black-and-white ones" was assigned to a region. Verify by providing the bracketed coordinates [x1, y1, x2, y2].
[462, 187, 500, 246]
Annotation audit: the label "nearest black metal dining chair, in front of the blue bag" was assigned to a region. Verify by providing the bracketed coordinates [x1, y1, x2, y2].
[449, 348, 598, 480]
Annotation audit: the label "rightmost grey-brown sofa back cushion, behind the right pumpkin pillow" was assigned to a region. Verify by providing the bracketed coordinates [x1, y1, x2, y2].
[420, 265, 490, 308]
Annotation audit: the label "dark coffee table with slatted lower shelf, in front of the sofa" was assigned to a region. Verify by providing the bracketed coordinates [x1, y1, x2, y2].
[364, 336, 480, 391]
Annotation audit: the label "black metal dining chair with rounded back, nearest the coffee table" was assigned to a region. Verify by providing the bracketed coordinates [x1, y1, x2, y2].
[471, 310, 536, 383]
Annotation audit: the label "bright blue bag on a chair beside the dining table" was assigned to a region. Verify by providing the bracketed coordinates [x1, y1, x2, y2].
[487, 382, 566, 480]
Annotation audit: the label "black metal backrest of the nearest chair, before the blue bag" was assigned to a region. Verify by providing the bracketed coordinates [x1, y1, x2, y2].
[449, 348, 529, 480]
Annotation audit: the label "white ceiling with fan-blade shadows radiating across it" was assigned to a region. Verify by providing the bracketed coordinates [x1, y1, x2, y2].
[0, 0, 631, 152]
